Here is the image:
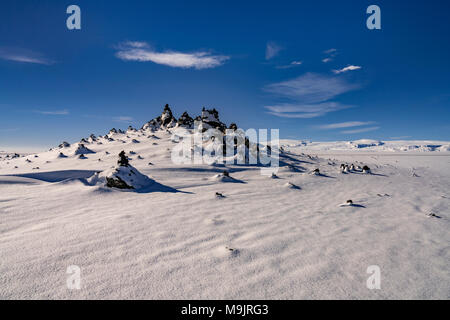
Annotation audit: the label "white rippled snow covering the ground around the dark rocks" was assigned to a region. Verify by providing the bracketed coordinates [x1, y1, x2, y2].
[0, 132, 450, 299]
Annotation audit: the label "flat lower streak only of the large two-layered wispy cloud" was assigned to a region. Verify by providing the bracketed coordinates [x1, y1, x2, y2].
[265, 102, 351, 119]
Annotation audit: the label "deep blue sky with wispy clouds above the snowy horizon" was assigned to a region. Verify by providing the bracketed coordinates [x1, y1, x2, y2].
[0, 0, 450, 149]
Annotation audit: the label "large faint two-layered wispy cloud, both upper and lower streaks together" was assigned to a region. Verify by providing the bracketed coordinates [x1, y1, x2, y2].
[264, 73, 359, 118]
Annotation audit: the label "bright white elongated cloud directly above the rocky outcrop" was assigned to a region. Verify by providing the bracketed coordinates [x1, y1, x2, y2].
[116, 41, 230, 69]
